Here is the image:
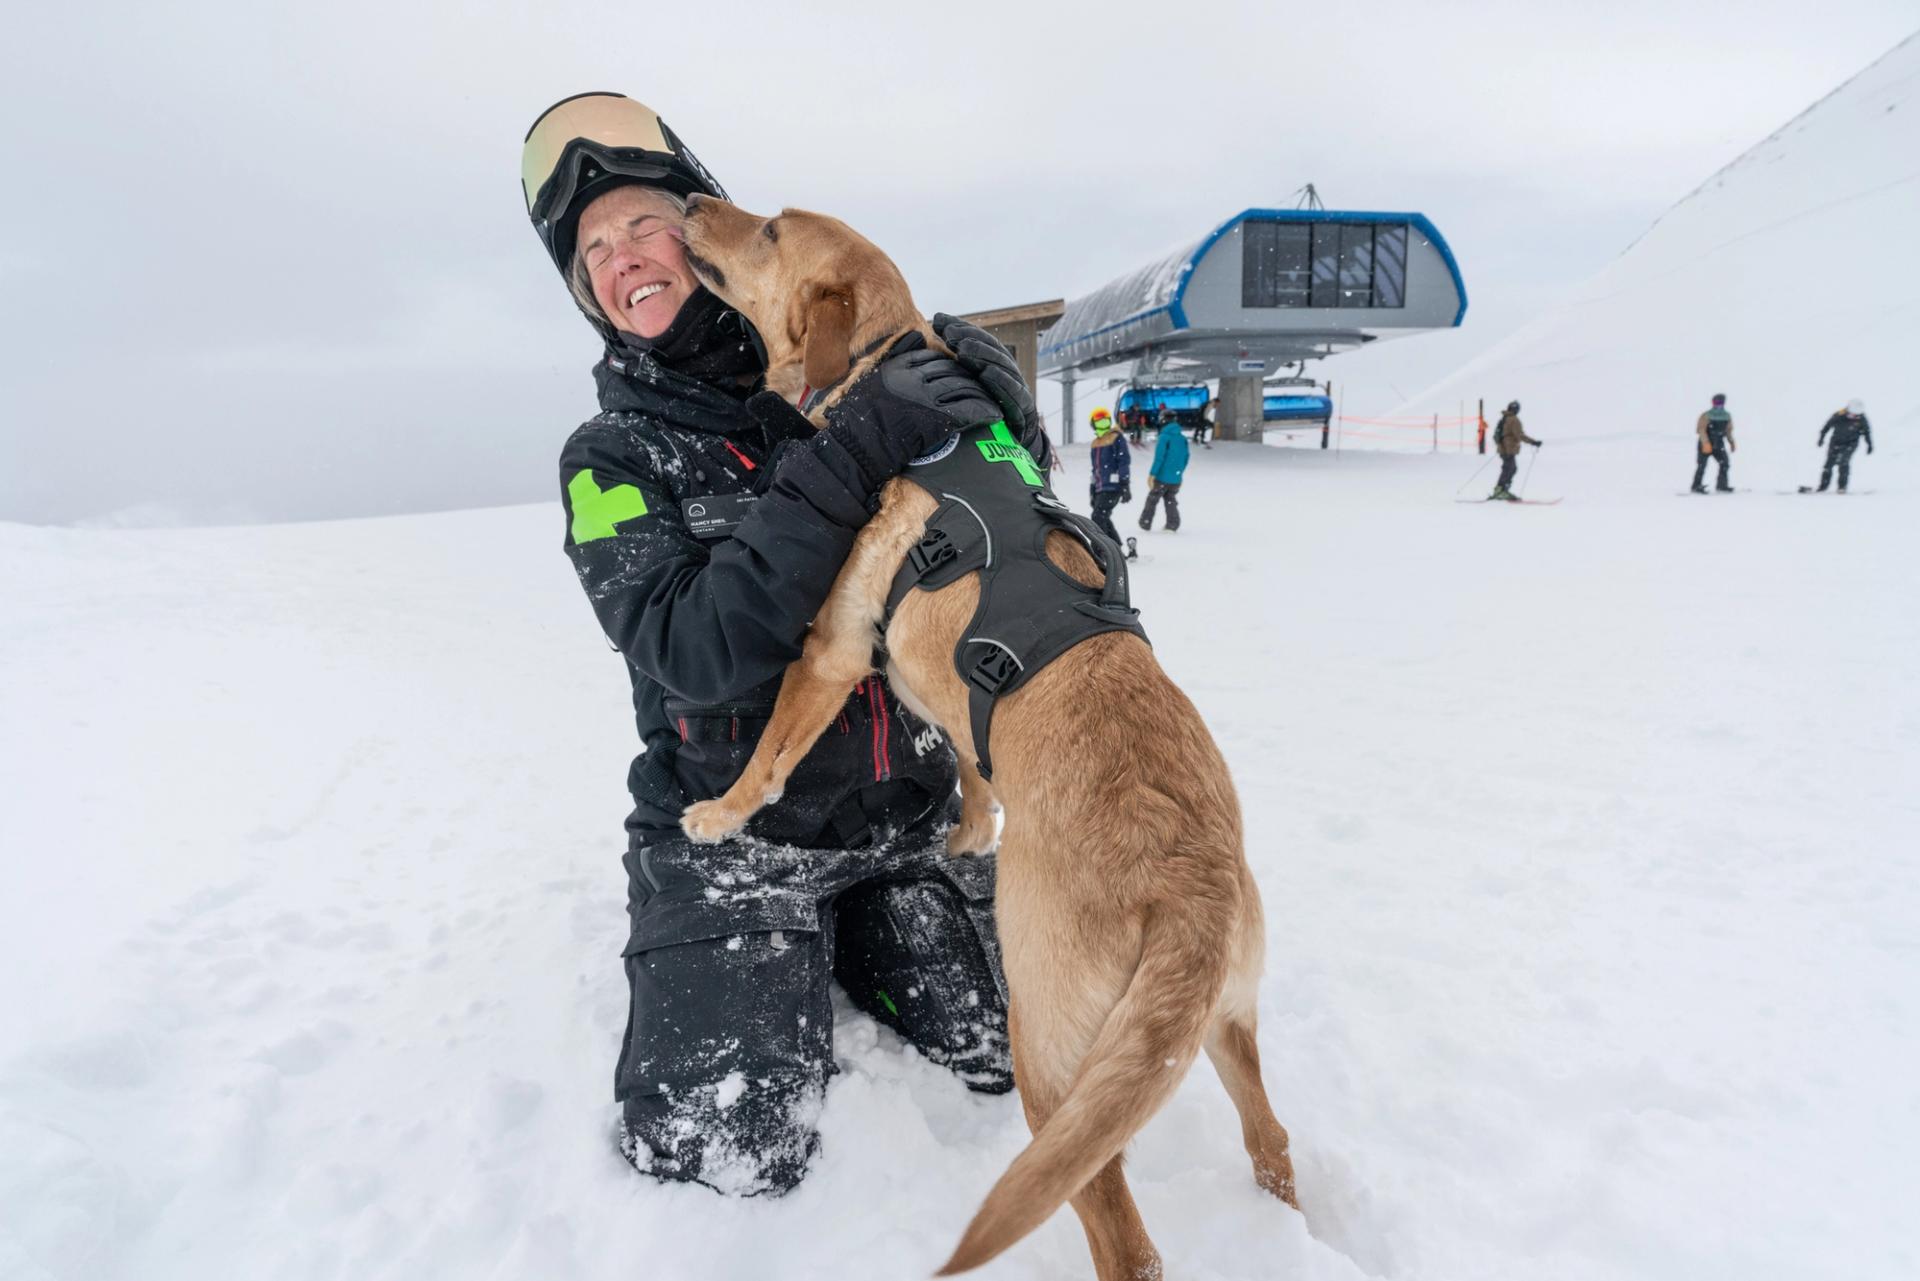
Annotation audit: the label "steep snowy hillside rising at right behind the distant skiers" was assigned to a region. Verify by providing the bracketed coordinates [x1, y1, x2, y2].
[1402, 35, 1920, 466]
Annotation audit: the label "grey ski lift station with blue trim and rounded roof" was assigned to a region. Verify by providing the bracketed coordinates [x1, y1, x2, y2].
[1035, 209, 1467, 440]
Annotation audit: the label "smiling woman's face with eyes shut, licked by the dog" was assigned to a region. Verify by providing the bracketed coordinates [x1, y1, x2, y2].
[574, 186, 699, 338]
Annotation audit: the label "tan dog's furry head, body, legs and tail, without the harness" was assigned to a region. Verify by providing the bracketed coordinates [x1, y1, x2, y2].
[682, 196, 1296, 1281]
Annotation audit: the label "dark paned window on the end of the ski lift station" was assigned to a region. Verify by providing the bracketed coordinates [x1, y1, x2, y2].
[1240, 219, 1407, 307]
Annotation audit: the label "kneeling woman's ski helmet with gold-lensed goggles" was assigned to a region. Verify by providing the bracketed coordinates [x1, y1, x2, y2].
[520, 94, 726, 277]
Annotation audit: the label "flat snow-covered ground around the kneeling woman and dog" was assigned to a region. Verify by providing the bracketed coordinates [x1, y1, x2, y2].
[0, 442, 1920, 1281]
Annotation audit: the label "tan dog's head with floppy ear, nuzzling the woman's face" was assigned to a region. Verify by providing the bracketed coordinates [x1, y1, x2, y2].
[685, 196, 925, 399]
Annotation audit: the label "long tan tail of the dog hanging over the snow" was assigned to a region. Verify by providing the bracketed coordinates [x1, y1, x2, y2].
[937, 903, 1231, 1277]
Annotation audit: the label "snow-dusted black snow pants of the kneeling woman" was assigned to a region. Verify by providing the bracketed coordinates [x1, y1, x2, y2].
[614, 784, 1014, 1196]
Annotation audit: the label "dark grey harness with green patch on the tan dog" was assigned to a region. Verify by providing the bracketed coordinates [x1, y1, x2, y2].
[881, 421, 1146, 778]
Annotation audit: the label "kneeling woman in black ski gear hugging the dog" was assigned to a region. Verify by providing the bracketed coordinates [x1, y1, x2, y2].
[522, 94, 1046, 1195]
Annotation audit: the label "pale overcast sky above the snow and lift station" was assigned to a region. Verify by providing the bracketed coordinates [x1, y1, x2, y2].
[0, 0, 1920, 522]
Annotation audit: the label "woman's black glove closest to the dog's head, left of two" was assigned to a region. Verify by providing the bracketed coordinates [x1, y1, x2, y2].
[826, 332, 1000, 490]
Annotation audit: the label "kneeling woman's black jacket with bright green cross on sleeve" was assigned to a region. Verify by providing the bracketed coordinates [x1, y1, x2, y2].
[561, 353, 954, 847]
